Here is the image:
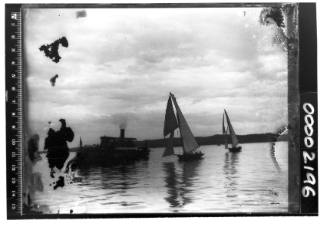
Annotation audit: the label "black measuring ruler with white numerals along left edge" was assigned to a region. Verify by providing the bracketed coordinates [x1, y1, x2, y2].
[5, 4, 24, 218]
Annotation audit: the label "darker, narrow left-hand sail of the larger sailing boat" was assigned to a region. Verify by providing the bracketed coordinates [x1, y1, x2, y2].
[162, 97, 178, 156]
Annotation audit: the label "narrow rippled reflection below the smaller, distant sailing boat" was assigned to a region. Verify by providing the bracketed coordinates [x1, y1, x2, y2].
[223, 152, 239, 200]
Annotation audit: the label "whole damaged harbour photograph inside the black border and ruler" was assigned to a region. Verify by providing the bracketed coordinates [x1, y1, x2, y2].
[3, 3, 313, 217]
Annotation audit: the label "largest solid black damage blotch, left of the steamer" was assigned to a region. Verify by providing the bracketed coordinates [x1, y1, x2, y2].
[44, 119, 74, 178]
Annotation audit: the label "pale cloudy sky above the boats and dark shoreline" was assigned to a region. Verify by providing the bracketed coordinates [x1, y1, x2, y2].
[24, 8, 287, 148]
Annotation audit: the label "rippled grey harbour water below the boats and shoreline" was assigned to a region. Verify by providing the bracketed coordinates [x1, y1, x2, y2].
[34, 142, 288, 214]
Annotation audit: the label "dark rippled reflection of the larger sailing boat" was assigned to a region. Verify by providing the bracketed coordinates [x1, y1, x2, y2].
[163, 161, 201, 208]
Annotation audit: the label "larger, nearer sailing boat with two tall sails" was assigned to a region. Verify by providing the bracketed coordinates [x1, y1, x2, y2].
[163, 93, 203, 161]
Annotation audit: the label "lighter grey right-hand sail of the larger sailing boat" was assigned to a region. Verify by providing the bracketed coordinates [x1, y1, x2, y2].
[170, 94, 199, 153]
